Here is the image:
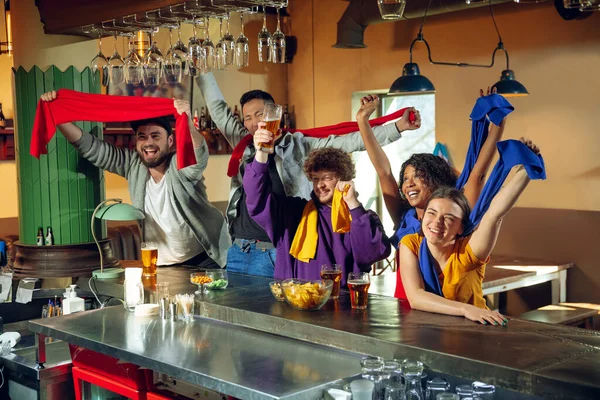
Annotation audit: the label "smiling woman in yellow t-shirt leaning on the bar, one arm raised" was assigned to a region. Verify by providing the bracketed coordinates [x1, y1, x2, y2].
[400, 139, 539, 325]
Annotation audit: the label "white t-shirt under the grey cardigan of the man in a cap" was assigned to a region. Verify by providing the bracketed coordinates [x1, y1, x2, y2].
[144, 176, 205, 265]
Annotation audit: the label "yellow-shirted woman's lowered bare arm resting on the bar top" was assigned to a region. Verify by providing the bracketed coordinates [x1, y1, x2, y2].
[400, 243, 505, 325]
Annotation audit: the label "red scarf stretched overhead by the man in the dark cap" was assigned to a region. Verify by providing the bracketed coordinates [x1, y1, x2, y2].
[29, 89, 196, 169]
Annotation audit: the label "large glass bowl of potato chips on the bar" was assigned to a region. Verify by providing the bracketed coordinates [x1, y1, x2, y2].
[281, 279, 333, 311]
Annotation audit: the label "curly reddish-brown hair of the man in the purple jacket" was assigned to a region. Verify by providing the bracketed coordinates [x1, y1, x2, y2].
[304, 147, 356, 181]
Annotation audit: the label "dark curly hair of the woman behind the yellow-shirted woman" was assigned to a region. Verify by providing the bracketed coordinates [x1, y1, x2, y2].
[399, 153, 458, 198]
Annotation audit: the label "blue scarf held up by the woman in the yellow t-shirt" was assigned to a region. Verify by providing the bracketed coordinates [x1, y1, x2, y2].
[419, 140, 546, 297]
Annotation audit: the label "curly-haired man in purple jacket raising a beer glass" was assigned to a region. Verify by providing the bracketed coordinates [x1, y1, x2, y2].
[244, 123, 390, 285]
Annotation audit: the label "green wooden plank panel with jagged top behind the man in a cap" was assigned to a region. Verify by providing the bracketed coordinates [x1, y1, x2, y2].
[14, 67, 104, 244]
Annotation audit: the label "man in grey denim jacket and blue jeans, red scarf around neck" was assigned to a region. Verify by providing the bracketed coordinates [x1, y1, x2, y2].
[196, 72, 421, 276]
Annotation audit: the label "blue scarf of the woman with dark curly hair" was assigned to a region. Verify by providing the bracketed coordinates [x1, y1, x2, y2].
[390, 94, 514, 248]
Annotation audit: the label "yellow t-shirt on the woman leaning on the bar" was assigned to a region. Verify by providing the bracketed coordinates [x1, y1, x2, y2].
[400, 233, 489, 309]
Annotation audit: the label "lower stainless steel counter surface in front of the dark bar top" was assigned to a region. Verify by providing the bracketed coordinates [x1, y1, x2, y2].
[30, 306, 360, 400]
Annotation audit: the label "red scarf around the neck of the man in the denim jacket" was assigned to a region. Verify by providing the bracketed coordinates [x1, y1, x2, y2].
[227, 108, 415, 177]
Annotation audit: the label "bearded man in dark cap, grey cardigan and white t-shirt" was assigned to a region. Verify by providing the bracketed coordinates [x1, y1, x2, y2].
[41, 91, 231, 275]
